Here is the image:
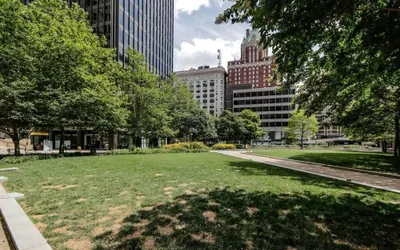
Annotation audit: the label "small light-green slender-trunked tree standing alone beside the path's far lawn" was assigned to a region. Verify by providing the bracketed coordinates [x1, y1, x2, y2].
[286, 109, 318, 149]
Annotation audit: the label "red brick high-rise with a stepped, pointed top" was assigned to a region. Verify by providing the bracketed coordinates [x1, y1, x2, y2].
[228, 30, 276, 88]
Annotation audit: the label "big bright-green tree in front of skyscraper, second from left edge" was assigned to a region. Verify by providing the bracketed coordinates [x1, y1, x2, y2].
[27, 0, 124, 153]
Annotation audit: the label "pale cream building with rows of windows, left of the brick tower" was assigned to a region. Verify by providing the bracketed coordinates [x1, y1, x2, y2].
[175, 66, 227, 116]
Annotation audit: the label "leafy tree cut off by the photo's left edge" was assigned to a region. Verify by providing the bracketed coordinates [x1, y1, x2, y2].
[0, 0, 37, 155]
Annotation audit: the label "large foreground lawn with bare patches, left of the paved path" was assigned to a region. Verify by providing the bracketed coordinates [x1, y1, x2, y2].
[1, 153, 400, 249]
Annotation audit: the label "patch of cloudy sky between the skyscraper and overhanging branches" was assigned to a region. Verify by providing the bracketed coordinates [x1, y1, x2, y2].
[174, 0, 250, 70]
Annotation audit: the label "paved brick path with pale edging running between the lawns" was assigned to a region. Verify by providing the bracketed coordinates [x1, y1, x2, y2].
[218, 151, 400, 194]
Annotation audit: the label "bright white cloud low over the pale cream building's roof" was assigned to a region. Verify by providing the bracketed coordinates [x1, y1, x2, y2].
[174, 38, 242, 71]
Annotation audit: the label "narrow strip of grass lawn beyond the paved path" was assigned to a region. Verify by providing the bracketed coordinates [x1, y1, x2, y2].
[248, 148, 400, 174]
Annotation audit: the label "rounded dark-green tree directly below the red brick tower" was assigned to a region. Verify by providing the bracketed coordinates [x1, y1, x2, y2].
[238, 109, 264, 144]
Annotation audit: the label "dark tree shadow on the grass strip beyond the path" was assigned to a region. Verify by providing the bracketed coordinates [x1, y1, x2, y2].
[289, 152, 400, 174]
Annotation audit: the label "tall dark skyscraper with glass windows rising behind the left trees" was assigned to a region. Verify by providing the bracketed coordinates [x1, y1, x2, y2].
[78, 0, 174, 76]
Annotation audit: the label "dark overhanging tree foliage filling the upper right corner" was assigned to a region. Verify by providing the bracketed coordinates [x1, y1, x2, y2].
[217, 0, 400, 156]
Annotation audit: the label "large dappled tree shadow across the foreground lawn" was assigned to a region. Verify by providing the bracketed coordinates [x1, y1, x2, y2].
[94, 189, 400, 250]
